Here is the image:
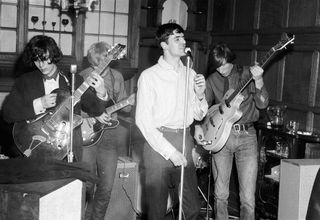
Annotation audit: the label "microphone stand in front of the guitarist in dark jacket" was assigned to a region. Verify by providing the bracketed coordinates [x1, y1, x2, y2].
[67, 65, 77, 163]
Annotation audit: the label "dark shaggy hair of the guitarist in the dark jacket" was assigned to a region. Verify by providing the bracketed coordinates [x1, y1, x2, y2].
[23, 35, 63, 66]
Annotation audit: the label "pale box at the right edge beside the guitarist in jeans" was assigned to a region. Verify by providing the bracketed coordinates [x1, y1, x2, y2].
[278, 159, 320, 220]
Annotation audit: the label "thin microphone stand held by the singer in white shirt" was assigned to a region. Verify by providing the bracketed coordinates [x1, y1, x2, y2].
[179, 53, 191, 220]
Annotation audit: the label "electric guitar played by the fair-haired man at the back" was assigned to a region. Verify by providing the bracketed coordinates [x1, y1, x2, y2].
[81, 94, 136, 147]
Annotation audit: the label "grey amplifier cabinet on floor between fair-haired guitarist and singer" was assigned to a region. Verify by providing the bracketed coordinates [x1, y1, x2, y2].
[104, 157, 138, 220]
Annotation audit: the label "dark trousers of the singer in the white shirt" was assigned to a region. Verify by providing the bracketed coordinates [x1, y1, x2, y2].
[144, 130, 200, 220]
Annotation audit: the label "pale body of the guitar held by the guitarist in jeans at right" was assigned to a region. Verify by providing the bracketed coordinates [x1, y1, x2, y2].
[202, 89, 243, 153]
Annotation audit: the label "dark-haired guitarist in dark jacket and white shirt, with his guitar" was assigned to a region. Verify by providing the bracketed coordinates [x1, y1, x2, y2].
[2, 35, 107, 161]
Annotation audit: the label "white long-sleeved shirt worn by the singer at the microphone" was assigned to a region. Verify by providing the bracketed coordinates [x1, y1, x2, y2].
[136, 56, 208, 159]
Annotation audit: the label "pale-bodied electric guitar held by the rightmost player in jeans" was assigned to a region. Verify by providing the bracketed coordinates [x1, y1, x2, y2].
[202, 34, 294, 153]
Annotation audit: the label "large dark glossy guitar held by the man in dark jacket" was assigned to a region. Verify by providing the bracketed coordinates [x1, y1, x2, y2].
[12, 44, 125, 160]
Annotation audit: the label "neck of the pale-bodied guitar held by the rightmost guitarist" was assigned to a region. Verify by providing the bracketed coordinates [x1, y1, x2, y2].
[226, 47, 277, 103]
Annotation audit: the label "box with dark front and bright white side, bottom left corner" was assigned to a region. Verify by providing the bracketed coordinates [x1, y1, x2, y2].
[0, 179, 85, 220]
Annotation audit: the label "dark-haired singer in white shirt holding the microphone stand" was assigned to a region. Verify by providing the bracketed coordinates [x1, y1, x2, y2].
[136, 23, 208, 220]
